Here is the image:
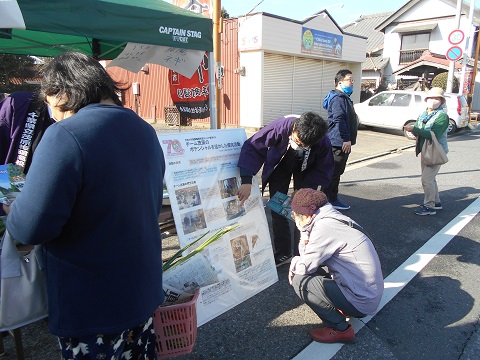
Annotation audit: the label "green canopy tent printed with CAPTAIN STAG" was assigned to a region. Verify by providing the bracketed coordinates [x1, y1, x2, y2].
[0, 0, 213, 60]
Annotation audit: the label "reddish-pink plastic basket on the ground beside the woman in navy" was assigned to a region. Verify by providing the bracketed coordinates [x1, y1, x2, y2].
[153, 290, 200, 359]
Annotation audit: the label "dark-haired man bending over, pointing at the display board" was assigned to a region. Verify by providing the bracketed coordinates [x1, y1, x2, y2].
[238, 112, 334, 265]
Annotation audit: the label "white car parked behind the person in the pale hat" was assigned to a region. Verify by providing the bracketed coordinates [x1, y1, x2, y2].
[354, 90, 470, 140]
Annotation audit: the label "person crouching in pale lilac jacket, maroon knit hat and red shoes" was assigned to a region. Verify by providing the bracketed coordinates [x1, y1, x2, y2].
[288, 188, 383, 343]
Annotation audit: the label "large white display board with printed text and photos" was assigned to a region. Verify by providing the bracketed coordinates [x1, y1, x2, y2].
[158, 129, 278, 326]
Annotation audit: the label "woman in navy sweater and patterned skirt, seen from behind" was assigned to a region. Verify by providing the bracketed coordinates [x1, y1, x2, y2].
[6, 52, 165, 359]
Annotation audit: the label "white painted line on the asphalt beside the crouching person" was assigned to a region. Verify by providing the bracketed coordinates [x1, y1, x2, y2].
[293, 198, 480, 360]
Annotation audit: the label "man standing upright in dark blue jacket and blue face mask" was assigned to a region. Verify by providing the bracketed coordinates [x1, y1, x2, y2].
[323, 69, 358, 210]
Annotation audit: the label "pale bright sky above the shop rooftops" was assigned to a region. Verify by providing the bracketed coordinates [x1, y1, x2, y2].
[221, 0, 408, 26]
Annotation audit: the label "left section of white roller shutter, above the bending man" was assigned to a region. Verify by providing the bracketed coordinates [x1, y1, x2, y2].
[262, 53, 293, 125]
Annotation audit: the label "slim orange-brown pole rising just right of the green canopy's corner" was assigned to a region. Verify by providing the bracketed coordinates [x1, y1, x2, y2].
[213, 0, 223, 129]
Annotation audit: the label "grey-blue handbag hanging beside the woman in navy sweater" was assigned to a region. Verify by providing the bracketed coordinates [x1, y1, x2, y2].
[0, 230, 48, 331]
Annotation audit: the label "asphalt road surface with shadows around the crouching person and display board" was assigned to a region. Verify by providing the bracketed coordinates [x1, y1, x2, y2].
[4, 124, 480, 360]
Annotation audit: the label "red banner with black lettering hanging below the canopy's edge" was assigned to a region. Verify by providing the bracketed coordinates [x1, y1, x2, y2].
[168, 53, 210, 119]
